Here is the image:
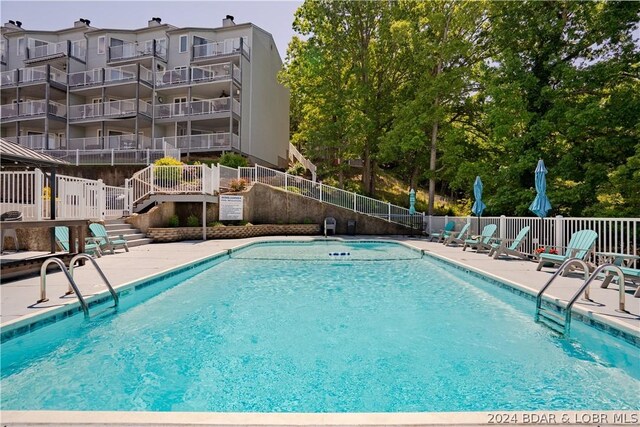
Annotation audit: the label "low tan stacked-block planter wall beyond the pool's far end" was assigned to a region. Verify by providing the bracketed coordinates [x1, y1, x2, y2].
[147, 224, 320, 243]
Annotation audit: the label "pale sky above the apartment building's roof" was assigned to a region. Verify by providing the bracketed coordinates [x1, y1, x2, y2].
[0, 0, 302, 60]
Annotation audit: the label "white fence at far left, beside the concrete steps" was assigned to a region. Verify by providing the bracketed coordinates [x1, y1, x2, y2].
[0, 169, 130, 220]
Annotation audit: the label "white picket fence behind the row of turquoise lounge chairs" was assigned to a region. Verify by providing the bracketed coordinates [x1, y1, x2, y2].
[425, 216, 640, 266]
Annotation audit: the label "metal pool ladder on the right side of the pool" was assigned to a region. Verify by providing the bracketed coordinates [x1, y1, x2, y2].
[535, 258, 625, 337]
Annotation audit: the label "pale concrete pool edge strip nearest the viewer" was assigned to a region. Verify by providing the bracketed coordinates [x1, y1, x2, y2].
[0, 411, 640, 426]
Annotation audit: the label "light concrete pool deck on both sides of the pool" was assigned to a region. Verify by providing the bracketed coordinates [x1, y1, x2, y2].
[0, 236, 640, 337]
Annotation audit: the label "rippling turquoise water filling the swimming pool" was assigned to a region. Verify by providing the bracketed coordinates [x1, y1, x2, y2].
[0, 242, 640, 412]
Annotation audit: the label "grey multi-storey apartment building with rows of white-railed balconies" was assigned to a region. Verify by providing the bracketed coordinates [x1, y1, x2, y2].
[0, 16, 289, 166]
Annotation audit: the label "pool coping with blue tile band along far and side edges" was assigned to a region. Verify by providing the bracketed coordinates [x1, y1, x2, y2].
[0, 237, 640, 348]
